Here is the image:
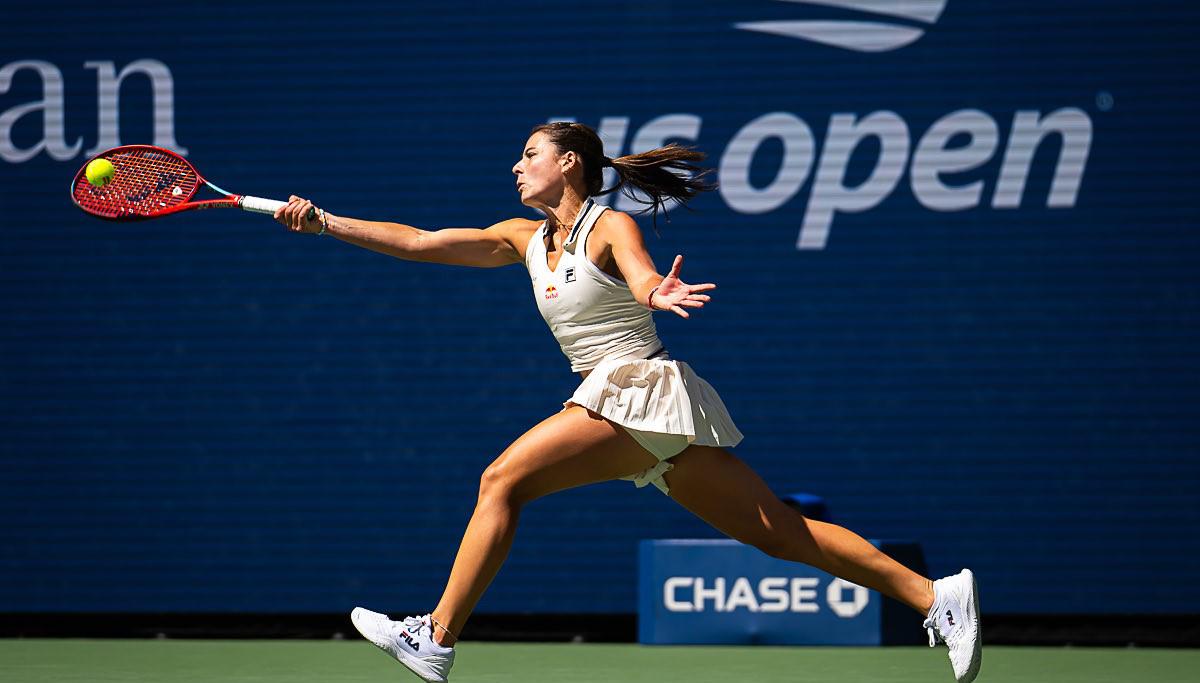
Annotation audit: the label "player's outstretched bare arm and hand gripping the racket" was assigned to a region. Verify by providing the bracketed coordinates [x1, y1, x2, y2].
[275, 194, 529, 268]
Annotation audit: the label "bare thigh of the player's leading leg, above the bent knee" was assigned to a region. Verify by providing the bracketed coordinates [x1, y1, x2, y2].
[481, 406, 658, 502]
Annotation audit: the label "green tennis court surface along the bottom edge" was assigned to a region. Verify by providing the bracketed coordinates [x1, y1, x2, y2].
[0, 640, 1200, 683]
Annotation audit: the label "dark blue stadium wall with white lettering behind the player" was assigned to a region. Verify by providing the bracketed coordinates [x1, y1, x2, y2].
[0, 0, 1200, 613]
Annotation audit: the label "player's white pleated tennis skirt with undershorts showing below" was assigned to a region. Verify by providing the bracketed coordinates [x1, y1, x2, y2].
[563, 359, 742, 493]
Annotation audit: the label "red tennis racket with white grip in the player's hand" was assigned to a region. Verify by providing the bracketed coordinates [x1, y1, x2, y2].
[71, 145, 317, 221]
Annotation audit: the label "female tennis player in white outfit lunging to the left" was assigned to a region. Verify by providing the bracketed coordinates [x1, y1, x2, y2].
[275, 122, 980, 682]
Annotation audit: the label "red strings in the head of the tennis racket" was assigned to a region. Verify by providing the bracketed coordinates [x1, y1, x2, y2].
[74, 149, 199, 218]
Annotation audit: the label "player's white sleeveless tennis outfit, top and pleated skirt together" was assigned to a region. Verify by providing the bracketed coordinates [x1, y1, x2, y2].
[526, 199, 742, 493]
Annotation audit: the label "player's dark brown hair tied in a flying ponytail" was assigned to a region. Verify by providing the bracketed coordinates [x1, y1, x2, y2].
[533, 121, 716, 222]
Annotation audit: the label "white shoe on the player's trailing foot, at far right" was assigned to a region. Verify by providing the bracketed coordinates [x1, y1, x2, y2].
[923, 569, 983, 683]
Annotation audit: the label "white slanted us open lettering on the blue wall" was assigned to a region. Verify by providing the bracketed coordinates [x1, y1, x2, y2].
[566, 108, 1092, 250]
